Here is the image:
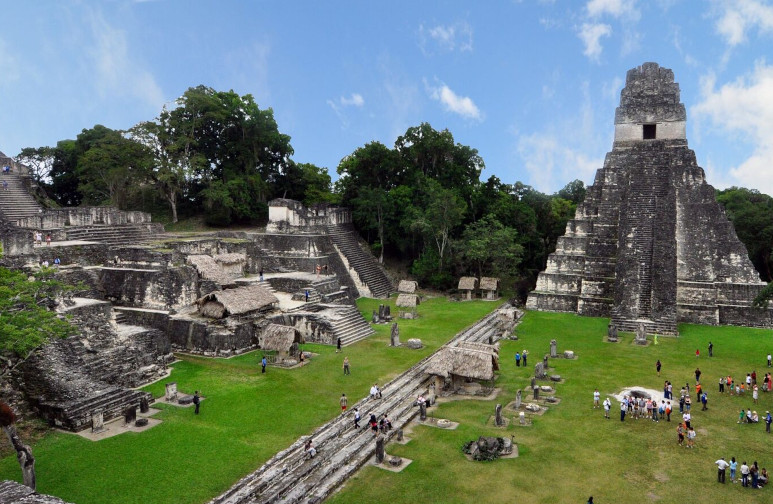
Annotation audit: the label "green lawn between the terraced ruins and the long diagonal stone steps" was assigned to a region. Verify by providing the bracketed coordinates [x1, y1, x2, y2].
[0, 298, 497, 504]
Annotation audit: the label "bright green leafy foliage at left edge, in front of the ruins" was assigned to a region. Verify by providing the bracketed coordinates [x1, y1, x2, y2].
[0, 268, 75, 358]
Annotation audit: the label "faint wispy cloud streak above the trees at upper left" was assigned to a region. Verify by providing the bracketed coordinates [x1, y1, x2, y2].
[86, 6, 164, 108]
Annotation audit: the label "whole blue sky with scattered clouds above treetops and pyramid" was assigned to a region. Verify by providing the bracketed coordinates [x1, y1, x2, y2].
[0, 0, 773, 194]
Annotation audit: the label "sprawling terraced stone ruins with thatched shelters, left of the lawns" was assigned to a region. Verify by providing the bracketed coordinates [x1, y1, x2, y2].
[0, 189, 395, 431]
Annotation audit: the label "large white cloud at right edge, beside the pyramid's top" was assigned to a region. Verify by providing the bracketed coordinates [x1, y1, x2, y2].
[691, 61, 773, 194]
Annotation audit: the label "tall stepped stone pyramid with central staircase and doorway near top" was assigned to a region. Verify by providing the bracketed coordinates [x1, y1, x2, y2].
[526, 63, 773, 335]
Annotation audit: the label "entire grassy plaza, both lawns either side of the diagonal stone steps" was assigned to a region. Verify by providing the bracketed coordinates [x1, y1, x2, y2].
[0, 298, 773, 504]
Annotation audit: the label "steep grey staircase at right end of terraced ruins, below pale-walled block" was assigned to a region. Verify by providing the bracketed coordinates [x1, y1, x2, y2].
[327, 225, 396, 298]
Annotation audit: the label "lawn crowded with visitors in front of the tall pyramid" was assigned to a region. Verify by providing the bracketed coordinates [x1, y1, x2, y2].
[329, 312, 773, 504]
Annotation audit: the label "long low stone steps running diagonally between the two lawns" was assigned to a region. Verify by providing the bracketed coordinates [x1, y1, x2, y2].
[210, 308, 515, 504]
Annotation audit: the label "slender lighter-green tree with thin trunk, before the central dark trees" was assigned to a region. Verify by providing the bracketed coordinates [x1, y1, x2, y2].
[413, 179, 467, 273]
